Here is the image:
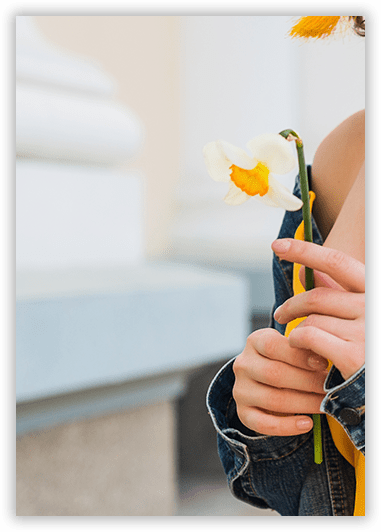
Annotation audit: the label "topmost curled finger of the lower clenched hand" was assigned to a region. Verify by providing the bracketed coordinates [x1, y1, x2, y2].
[248, 329, 327, 371]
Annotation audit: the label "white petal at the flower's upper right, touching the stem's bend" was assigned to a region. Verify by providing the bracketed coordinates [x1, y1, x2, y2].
[247, 133, 296, 174]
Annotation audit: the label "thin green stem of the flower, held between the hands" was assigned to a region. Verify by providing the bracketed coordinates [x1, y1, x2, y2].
[279, 129, 323, 464]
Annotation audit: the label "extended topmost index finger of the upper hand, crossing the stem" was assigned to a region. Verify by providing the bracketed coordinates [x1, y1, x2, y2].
[272, 238, 365, 292]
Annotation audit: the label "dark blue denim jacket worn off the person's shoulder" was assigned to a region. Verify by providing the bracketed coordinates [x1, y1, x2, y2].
[207, 167, 365, 516]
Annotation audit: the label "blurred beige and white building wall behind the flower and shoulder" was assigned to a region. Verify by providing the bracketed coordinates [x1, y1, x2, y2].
[34, 16, 365, 262]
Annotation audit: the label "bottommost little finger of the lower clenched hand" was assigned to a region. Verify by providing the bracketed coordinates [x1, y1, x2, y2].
[237, 407, 313, 436]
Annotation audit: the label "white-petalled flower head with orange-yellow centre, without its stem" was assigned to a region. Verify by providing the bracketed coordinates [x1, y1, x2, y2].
[204, 133, 303, 211]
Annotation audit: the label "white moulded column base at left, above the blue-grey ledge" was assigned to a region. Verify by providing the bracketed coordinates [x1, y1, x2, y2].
[16, 16, 144, 271]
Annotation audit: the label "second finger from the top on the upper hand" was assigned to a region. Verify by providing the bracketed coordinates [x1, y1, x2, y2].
[274, 288, 364, 323]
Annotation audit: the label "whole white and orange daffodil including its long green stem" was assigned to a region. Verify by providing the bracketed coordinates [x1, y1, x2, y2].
[204, 129, 323, 464]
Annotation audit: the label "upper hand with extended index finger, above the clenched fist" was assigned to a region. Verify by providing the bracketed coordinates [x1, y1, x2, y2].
[272, 238, 365, 380]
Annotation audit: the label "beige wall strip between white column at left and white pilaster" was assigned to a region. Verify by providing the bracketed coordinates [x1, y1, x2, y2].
[34, 16, 180, 256]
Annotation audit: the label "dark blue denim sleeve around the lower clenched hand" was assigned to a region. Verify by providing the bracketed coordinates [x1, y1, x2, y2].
[207, 359, 340, 516]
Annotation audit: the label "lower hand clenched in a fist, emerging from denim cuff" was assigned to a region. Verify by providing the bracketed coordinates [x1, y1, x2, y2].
[233, 329, 327, 436]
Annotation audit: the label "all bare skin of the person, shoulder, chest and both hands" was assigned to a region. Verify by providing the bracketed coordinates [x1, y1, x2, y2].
[233, 111, 365, 436]
